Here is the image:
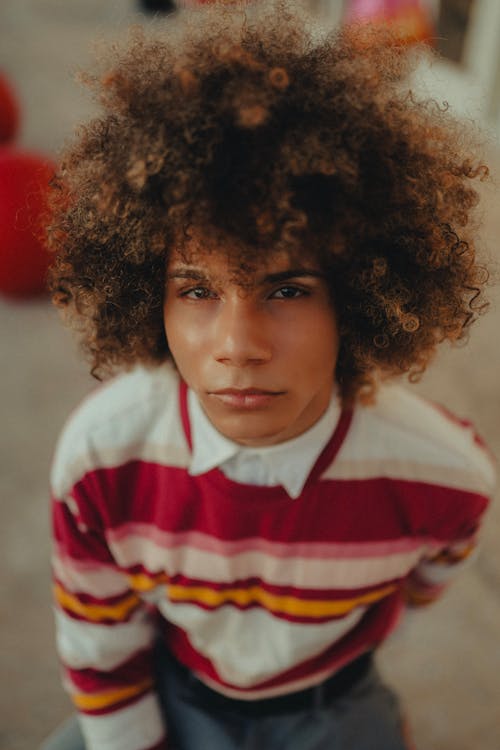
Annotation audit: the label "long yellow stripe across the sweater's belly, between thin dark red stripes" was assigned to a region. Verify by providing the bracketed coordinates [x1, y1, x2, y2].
[168, 585, 396, 617]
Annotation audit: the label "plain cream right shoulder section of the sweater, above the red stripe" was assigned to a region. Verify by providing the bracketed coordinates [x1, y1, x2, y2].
[328, 384, 495, 495]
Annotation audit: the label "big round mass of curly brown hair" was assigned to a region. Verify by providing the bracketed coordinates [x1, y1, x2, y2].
[48, 0, 488, 400]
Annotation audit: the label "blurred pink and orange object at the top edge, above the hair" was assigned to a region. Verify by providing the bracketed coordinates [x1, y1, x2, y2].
[345, 0, 435, 44]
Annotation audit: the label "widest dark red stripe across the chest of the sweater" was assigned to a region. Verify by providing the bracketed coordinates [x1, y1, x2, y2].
[74, 461, 488, 544]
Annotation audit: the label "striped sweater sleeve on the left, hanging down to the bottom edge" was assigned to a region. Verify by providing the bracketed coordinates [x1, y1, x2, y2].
[53, 482, 167, 750]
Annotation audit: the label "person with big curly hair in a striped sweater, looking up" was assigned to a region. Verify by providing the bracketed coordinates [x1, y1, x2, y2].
[44, 2, 494, 750]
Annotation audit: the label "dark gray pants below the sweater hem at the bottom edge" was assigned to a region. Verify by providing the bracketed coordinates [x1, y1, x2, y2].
[41, 663, 408, 750]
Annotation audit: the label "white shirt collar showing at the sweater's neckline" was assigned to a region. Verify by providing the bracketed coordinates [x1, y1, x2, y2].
[188, 389, 341, 498]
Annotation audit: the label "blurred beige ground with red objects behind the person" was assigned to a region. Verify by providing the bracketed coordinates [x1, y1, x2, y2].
[0, 0, 500, 750]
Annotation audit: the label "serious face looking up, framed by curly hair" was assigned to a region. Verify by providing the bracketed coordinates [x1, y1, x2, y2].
[164, 245, 338, 446]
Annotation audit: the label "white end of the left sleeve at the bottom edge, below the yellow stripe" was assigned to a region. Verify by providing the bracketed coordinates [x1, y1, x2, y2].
[79, 693, 165, 750]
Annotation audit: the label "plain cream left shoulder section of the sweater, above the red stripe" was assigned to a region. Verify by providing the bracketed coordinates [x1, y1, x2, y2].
[51, 364, 187, 497]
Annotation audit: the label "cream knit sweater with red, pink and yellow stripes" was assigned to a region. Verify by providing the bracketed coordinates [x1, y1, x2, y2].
[51, 365, 494, 750]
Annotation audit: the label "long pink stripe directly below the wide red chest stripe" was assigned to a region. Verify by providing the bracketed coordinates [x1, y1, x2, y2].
[106, 523, 442, 560]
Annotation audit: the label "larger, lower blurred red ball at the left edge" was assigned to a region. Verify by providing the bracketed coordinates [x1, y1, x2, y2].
[0, 146, 56, 298]
